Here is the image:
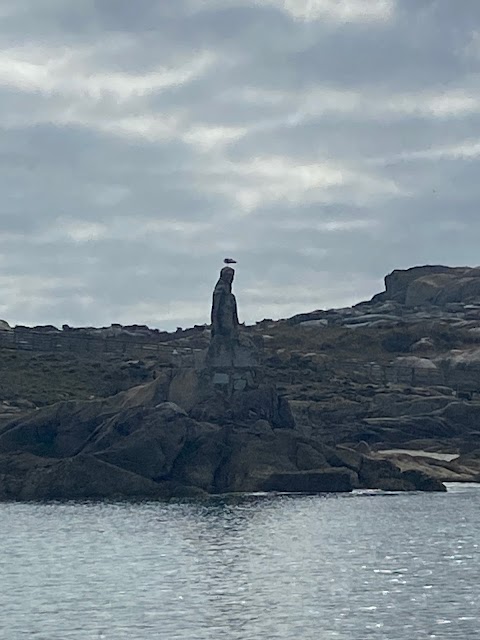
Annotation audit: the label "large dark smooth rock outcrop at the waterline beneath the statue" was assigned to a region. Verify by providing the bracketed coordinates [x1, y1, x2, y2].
[0, 382, 441, 500]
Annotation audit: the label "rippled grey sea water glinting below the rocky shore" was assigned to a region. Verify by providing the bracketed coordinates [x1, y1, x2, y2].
[0, 486, 480, 640]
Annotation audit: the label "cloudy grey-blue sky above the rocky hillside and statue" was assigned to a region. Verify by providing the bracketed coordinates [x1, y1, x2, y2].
[0, 0, 480, 330]
